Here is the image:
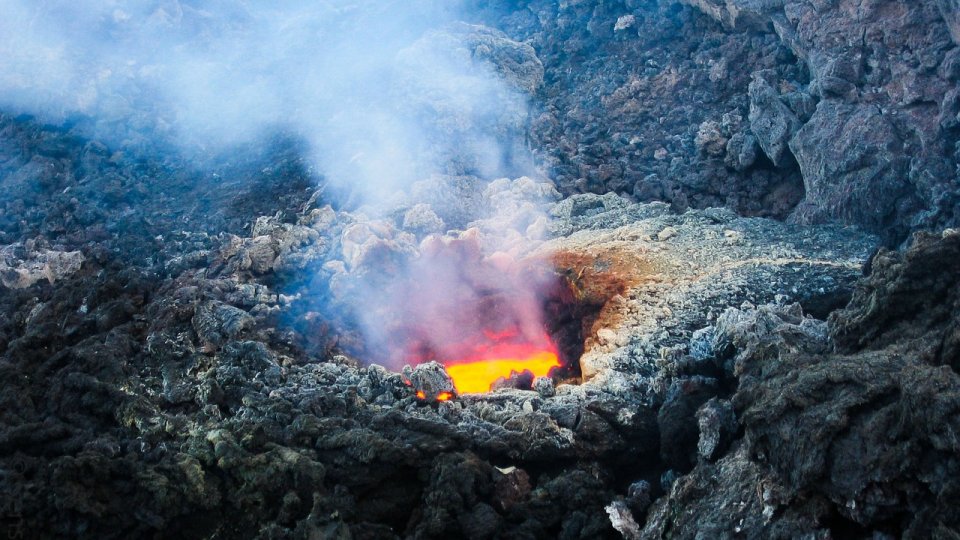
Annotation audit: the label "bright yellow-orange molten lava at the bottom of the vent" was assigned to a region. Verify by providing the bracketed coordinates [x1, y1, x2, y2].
[442, 343, 560, 394]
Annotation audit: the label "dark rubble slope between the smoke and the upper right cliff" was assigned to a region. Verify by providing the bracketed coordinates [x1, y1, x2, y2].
[477, 1, 807, 217]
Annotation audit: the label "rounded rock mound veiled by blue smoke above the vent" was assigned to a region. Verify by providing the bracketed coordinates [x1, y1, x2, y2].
[389, 23, 543, 180]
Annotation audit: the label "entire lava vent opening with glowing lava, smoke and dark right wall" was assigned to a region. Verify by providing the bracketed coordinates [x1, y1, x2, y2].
[344, 230, 636, 399]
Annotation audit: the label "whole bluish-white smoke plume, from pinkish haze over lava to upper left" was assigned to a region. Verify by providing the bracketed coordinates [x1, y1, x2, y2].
[0, 0, 560, 376]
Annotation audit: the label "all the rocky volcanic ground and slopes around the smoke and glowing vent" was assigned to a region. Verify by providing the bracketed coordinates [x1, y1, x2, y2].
[0, 0, 960, 539]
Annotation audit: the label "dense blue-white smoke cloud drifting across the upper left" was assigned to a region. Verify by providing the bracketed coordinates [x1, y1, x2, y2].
[0, 0, 536, 202]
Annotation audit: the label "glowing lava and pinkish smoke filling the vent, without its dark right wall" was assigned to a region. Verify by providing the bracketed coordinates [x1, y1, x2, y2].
[361, 229, 566, 392]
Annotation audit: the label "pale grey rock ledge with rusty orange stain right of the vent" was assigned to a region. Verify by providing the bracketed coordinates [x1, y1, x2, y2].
[537, 194, 876, 378]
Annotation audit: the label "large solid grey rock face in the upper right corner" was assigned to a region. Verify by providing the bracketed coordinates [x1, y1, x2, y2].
[684, 0, 956, 239]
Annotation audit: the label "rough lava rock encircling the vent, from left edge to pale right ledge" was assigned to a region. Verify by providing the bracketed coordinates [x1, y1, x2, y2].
[0, 113, 876, 538]
